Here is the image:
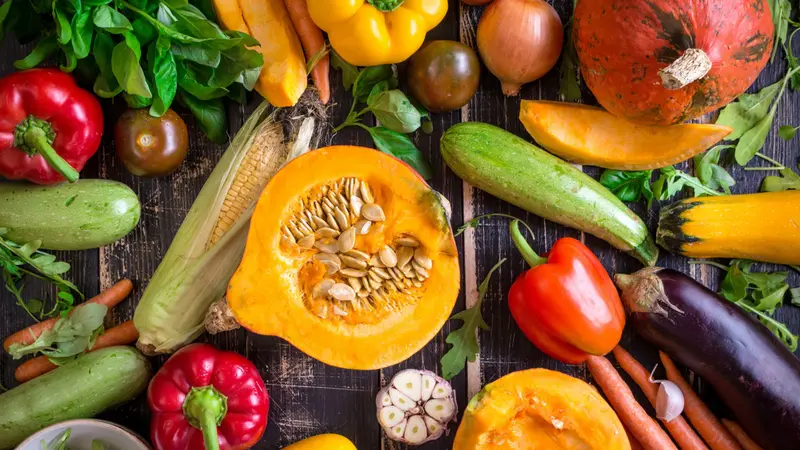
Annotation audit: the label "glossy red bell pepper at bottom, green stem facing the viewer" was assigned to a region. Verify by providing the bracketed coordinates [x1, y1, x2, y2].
[147, 344, 269, 450]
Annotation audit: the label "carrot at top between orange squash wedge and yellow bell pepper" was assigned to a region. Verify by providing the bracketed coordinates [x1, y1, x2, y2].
[284, 0, 331, 105]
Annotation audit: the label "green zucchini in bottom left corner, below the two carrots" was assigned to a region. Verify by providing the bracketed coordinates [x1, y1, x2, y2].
[0, 346, 152, 449]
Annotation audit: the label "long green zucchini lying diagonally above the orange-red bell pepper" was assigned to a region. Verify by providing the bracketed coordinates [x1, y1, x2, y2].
[441, 122, 658, 266]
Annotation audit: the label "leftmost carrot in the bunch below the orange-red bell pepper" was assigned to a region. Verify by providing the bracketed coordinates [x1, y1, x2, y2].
[586, 356, 678, 450]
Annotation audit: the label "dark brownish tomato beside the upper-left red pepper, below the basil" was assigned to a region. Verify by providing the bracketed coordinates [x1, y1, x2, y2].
[114, 108, 189, 177]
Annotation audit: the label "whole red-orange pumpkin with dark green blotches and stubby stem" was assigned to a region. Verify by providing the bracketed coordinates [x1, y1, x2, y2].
[574, 0, 774, 125]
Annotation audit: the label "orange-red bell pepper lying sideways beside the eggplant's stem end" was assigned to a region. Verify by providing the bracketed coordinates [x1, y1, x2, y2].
[508, 220, 625, 364]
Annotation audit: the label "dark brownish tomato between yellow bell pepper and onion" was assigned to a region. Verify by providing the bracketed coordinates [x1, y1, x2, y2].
[408, 41, 481, 112]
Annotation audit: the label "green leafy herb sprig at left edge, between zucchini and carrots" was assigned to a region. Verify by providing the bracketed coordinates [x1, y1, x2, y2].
[0, 228, 83, 320]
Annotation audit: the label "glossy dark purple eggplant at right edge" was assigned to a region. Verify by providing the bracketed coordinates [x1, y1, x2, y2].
[615, 267, 800, 450]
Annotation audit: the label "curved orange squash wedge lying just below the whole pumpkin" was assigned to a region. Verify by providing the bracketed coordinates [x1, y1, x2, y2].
[519, 100, 733, 170]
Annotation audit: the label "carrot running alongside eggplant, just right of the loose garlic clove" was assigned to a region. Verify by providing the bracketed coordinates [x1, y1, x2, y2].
[658, 352, 742, 450]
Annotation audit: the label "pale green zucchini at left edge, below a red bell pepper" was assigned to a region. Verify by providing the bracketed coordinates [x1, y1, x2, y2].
[0, 180, 141, 250]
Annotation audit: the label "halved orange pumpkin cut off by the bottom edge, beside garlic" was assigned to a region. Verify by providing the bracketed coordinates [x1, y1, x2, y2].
[453, 369, 631, 450]
